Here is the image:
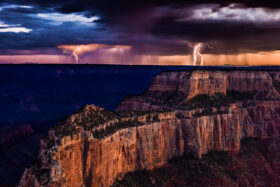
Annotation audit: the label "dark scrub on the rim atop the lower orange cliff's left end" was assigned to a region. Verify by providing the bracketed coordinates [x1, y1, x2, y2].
[47, 105, 172, 139]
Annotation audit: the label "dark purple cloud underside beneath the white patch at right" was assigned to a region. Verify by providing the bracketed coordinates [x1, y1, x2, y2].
[151, 15, 280, 53]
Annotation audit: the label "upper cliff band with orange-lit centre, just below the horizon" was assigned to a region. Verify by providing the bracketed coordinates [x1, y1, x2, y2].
[149, 70, 279, 98]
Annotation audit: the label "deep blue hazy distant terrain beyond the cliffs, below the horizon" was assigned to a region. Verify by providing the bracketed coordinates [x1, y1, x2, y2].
[0, 65, 195, 131]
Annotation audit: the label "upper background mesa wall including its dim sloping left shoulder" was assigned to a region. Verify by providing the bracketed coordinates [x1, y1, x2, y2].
[116, 70, 280, 111]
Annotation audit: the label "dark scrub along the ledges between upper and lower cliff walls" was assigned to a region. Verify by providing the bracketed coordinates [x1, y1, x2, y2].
[49, 90, 272, 139]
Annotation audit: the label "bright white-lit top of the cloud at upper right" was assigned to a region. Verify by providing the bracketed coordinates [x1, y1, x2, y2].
[179, 4, 280, 23]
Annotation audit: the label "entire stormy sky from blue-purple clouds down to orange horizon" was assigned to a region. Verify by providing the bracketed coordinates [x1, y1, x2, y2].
[0, 0, 280, 65]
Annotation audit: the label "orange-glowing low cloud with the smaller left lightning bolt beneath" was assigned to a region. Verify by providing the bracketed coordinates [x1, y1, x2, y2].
[57, 44, 131, 63]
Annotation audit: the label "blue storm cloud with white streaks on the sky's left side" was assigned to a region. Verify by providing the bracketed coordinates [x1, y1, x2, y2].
[0, 4, 115, 54]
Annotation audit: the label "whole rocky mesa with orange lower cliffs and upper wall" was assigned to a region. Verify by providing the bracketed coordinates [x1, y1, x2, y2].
[19, 70, 280, 187]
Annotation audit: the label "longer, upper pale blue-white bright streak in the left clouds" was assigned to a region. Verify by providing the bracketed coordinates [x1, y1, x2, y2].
[37, 13, 99, 25]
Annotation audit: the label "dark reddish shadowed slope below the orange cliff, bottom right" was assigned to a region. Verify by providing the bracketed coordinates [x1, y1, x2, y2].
[114, 138, 280, 187]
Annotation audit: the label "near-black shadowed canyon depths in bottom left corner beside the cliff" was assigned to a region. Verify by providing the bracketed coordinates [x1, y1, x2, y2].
[0, 124, 42, 187]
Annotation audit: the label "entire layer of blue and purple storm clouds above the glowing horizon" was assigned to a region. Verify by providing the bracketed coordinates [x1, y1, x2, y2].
[0, 0, 280, 55]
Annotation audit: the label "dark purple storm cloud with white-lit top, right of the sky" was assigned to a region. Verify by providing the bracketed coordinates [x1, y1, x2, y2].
[148, 4, 280, 53]
